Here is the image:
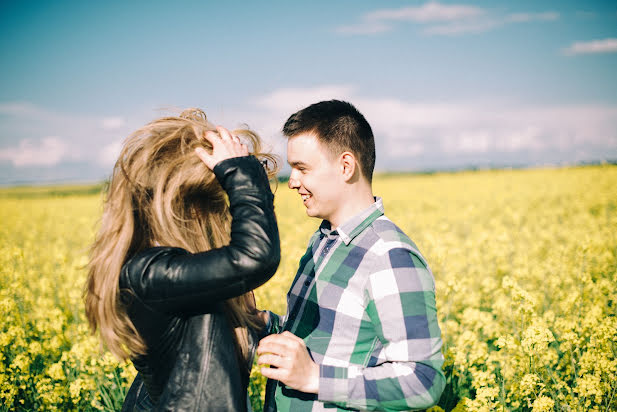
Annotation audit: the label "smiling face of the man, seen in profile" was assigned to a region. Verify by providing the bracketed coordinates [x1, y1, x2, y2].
[287, 133, 344, 221]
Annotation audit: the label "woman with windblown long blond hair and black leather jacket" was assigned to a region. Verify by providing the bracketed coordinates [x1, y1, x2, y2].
[85, 109, 280, 411]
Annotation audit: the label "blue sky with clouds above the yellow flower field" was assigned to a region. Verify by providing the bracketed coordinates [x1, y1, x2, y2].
[0, 0, 617, 184]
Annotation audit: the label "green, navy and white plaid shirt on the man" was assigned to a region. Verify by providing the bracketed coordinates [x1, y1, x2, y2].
[266, 198, 445, 412]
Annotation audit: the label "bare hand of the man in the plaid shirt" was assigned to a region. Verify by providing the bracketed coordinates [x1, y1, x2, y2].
[257, 331, 319, 393]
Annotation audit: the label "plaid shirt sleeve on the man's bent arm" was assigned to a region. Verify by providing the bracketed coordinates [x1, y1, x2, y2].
[318, 248, 445, 410]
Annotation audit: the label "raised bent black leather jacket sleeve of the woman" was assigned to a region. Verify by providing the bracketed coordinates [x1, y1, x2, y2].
[120, 156, 280, 314]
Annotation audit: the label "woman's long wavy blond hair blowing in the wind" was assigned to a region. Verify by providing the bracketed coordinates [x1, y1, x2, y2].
[84, 109, 277, 366]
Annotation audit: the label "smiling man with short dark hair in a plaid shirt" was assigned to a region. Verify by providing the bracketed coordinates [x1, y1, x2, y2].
[257, 100, 445, 412]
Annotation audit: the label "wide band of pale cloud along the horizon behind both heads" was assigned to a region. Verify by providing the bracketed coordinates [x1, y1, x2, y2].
[0, 91, 617, 180]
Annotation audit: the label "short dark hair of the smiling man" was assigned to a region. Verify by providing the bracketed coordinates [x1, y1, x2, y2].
[283, 100, 375, 182]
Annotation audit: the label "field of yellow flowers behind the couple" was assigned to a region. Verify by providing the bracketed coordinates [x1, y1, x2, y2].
[0, 166, 617, 411]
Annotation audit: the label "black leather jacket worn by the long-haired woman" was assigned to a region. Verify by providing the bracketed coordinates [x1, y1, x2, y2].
[120, 156, 280, 411]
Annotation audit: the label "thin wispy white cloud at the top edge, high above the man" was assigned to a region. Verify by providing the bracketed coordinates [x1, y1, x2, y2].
[336, 1, 560, 36]
